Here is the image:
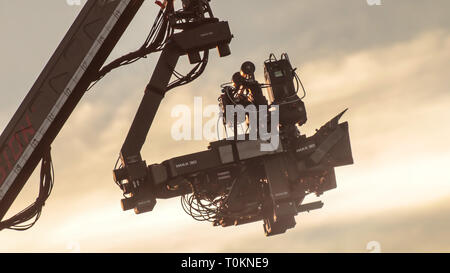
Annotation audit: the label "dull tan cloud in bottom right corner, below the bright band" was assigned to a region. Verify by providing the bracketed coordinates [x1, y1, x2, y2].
[220, 194, 450, 252]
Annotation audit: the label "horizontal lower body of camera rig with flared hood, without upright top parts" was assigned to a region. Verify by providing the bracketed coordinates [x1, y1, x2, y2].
[122, 111, 353, 235]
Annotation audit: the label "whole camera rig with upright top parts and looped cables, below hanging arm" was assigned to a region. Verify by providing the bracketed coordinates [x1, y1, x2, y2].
[114, 54, 353, 236]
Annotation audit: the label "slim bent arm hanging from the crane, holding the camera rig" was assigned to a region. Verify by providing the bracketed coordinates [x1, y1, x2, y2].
[113, 19, 233, 213]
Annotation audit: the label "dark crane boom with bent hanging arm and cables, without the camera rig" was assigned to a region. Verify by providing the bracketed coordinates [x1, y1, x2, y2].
[0, 0, 232, 230]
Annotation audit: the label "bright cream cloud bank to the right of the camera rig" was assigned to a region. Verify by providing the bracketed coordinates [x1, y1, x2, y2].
[301, 31, 450, 216]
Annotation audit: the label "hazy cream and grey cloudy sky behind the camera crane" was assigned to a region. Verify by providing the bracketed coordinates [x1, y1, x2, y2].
[0, 0, 450, 252]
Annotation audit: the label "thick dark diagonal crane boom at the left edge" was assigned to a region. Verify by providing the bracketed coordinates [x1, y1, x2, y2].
[0, 0, 148, 230]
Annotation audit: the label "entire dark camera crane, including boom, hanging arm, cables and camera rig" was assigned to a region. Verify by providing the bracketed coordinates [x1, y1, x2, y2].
[0, 0, 353, 235]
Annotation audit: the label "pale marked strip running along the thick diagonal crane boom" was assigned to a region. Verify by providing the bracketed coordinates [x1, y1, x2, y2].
[0, 0, 131, 200]
